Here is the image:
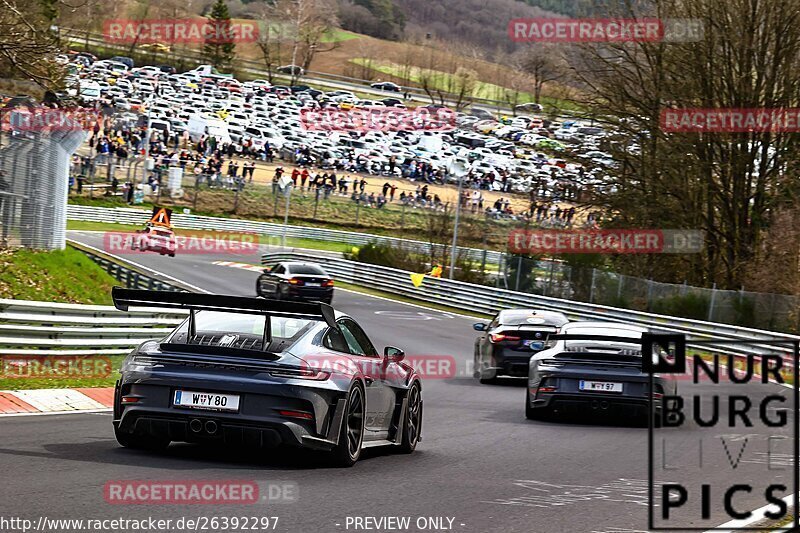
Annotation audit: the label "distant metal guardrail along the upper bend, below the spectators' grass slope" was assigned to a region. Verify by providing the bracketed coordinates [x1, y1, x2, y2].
[67, 205, 503, 264]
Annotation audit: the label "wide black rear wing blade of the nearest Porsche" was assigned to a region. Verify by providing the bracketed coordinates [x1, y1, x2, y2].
[111, 287, 338, 328]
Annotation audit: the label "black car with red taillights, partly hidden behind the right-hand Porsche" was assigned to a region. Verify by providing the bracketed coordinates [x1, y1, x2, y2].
[473, 309, 569, 383]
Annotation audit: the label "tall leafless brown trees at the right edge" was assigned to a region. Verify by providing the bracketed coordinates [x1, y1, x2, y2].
[575, 0, 800, 289]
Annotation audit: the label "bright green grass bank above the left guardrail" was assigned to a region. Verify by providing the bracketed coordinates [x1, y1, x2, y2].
[0, 248, 116, 305]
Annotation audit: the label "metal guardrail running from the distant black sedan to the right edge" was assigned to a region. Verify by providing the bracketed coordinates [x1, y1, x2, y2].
[261, 253, 800, 358]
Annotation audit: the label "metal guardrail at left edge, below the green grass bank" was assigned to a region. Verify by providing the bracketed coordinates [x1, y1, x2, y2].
[0, 299, 186, 356]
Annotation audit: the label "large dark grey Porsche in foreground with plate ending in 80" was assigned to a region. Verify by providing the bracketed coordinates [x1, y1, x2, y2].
[113, 287, 422, 466]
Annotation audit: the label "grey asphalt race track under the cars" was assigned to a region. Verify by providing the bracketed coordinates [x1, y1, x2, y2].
[0, 232, 792, 533]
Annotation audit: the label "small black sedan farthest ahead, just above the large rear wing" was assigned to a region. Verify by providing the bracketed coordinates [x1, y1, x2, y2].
[256, 261, 333, 304]
